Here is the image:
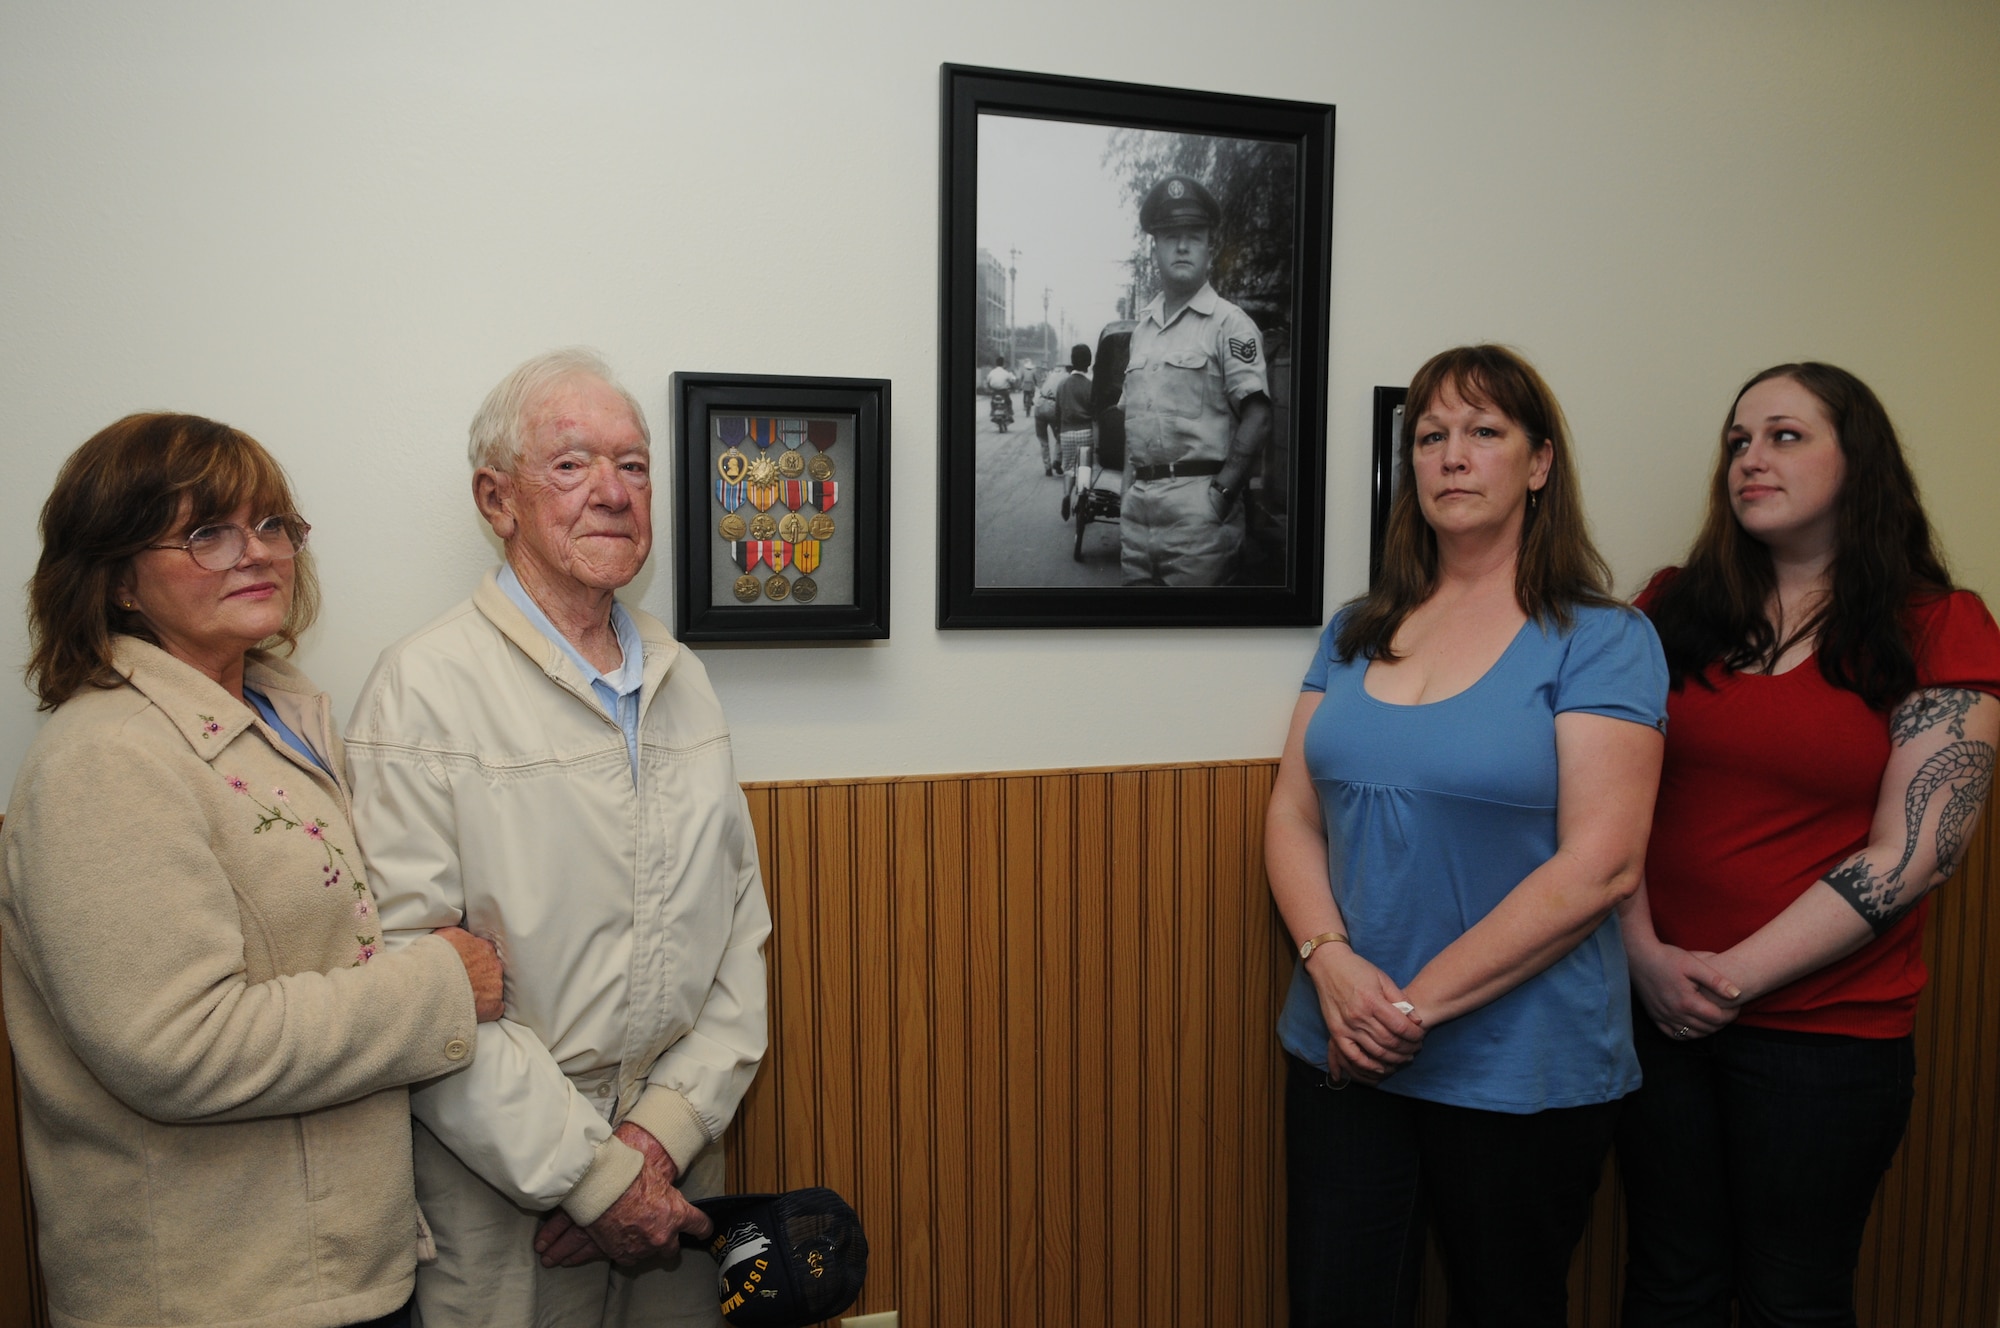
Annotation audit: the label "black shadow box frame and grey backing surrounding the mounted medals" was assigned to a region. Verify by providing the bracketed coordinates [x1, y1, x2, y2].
[670, 374, 890, 642]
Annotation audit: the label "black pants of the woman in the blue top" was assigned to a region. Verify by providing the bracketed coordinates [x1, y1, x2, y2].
[1284, 1056, 1618, 1328]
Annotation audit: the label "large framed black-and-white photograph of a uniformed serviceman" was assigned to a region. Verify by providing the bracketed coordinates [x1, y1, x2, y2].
[938, 66, 1334, 628]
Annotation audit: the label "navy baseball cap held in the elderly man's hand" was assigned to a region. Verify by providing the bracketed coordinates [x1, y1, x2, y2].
[694, 1186, 868, 1328]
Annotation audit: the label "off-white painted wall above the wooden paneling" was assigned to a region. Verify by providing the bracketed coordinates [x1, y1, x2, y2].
[0, 0, 2000, 778]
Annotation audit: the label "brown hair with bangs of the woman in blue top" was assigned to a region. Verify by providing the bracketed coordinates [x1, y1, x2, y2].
[1334, 346, 1616, 662]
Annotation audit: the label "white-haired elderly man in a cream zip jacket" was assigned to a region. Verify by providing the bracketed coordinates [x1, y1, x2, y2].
[348, 350, 770, 1328]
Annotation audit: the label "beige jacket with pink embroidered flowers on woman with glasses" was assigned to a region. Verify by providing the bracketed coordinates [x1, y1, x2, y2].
[0, 636, 474, 1328]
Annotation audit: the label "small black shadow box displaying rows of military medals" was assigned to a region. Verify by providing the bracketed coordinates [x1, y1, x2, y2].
[670, 374, 890, 642]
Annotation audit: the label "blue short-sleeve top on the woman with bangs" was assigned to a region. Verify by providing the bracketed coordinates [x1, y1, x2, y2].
[1278, 606, 1666, 1112]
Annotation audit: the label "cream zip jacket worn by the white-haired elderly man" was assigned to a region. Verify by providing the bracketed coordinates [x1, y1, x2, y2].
[348, 574, 770, 1224]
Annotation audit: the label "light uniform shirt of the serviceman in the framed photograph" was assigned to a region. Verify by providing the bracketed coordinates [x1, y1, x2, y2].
[1124, 282, 1270, 466]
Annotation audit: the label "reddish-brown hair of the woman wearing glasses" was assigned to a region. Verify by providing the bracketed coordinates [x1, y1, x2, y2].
[26, 414, 320, 710]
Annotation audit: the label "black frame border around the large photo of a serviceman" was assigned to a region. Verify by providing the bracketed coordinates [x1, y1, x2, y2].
[938, 64, 1334, 630]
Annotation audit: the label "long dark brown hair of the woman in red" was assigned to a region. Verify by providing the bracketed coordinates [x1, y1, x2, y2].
[1646, 362, 1952, 710]
